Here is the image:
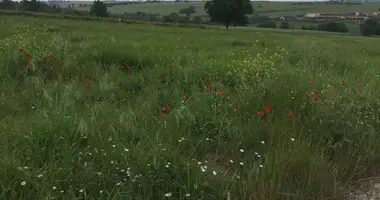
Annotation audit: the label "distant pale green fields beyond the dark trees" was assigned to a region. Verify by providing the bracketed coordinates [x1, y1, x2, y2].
[72, 2, 380, 17]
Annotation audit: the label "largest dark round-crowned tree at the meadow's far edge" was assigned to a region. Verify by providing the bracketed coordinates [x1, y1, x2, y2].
[205, 0, 253, 29]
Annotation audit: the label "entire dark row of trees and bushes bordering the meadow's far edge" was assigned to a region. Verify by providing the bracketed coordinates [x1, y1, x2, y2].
[0, 0, 380, 36]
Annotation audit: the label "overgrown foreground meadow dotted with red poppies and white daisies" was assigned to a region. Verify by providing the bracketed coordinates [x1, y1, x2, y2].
[0, 16, 380, 200]
